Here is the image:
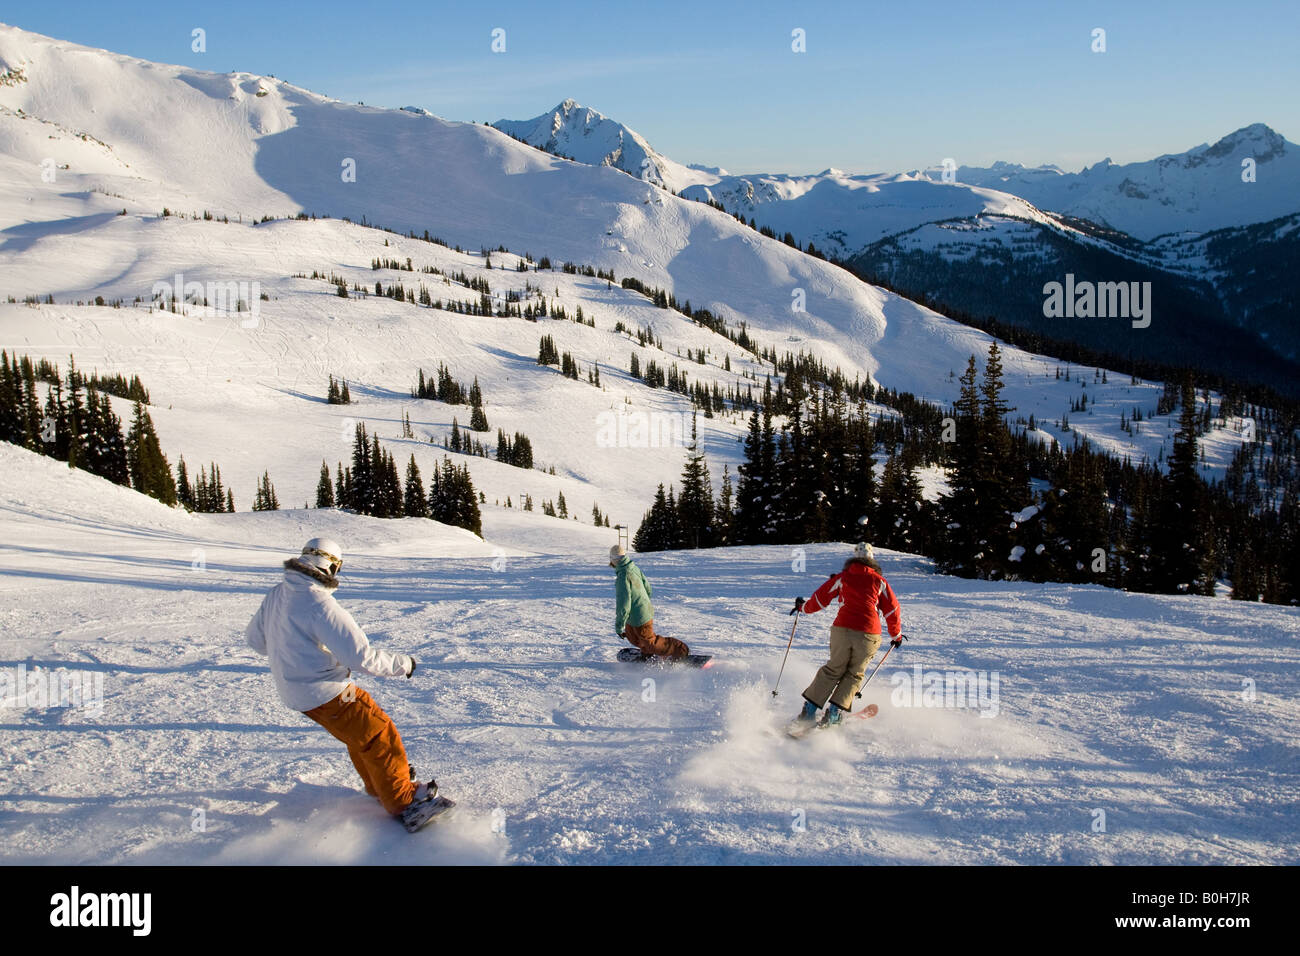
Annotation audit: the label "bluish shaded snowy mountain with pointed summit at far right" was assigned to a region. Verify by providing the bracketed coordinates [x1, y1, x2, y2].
[946, 122, 1300, 239]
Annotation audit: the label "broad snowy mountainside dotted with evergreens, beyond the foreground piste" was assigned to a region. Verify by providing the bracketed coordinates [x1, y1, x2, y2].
[0, 27, 1239, 522]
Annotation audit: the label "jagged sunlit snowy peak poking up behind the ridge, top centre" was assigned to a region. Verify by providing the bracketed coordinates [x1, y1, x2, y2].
[493, 99, 718, 193]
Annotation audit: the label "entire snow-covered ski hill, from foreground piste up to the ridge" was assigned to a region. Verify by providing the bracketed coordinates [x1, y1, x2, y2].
[0, 27, 1300, 864]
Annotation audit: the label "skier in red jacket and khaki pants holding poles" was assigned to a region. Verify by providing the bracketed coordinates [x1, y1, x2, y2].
[790, 542, 902, 726]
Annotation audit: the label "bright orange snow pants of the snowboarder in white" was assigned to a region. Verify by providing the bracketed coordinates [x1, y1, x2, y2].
[303, 684, 416, 814]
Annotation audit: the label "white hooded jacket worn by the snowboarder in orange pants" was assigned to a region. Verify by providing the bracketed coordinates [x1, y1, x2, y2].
[244, 568, 412, 710]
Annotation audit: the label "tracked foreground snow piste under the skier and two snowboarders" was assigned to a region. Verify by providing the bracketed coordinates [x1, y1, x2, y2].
[0, 449, 1300, 864]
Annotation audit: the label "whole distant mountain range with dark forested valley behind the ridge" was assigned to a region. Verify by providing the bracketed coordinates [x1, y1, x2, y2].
[495, 100, 1300, 390]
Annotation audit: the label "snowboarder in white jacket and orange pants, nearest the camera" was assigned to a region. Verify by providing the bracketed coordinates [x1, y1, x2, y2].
[244, 537, 438, 817]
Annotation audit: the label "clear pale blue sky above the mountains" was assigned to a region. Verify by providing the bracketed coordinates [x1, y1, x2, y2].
[0, 0, 1300, 173]
